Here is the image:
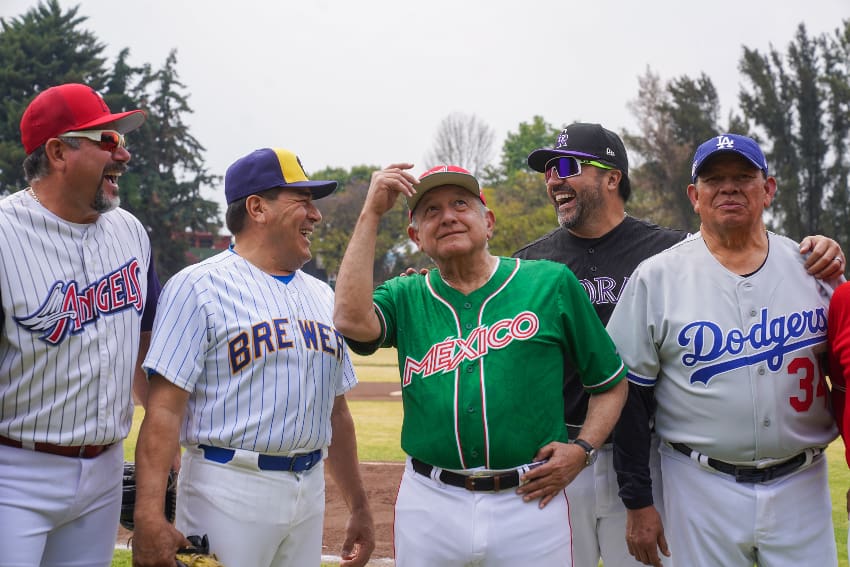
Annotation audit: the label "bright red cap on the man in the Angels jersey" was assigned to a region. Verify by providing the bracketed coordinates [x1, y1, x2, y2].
[21, 83, 145, 155]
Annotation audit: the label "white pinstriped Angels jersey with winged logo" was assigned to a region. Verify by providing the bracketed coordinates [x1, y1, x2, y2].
[0, 191, 159, 445]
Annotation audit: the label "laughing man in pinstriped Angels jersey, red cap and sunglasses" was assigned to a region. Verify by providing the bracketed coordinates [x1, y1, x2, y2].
[0, 84, 159, 566]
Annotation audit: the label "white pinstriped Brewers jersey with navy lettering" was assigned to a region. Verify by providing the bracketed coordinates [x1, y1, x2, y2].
[144, 250, 357, 454]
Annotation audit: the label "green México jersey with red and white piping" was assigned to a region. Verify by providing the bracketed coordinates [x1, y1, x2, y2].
[350, 258, 625, 469]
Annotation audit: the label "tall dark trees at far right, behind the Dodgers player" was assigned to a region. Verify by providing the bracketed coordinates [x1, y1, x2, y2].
[740, 22, 850, 243]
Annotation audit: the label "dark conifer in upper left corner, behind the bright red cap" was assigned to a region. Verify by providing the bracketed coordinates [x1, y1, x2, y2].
[0, 0, 109, 195]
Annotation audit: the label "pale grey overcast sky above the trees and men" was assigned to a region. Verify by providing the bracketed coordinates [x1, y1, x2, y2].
[0, 0, 850, 214]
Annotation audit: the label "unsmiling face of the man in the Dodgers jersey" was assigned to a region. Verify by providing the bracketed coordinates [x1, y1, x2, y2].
[688, 152, 776, 234]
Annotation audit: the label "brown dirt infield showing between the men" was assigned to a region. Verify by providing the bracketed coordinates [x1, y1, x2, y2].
[116, 382, 404, 565]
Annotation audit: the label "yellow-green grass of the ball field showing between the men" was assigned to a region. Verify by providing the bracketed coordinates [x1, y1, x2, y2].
[112, 349, 850, 567]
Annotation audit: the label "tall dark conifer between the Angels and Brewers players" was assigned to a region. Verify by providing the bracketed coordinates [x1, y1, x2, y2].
[121, 51, 220, 281]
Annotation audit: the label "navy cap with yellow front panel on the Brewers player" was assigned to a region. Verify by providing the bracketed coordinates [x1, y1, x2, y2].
[224, 148, 337, 205]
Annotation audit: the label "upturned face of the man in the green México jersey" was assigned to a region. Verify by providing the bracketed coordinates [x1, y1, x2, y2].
[407, 185, 495, 265]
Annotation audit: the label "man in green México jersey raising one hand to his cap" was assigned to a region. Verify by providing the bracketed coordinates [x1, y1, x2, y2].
[334, 163, 627, 567]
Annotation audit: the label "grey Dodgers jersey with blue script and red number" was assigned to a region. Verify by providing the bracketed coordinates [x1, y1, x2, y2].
[608, 233, 836, 465]
